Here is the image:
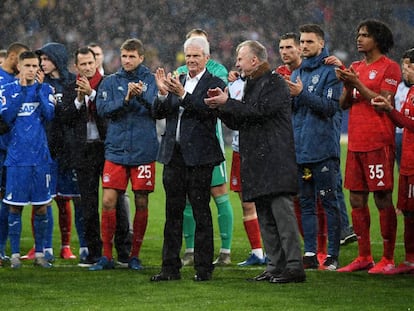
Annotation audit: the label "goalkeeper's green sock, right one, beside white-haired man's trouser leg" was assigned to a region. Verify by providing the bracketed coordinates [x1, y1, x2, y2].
[214, 193, 233, 253]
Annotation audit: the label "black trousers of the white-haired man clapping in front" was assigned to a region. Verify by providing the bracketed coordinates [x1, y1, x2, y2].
[162, 147, 214, 273]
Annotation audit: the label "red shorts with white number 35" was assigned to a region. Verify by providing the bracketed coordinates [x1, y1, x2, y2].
[344, 146, 395, 192]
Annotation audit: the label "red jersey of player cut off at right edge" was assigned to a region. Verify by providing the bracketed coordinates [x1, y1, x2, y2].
[400, 86, 414, 176]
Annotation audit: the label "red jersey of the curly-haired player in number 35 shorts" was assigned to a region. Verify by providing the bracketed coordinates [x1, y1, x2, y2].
[348, 56, 401, 152]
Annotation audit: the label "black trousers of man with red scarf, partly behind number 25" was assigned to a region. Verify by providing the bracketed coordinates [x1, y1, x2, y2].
[76, 142, 132, 261]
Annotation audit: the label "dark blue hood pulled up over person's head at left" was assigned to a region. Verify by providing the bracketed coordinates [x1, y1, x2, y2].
[36, 42, 70, 82]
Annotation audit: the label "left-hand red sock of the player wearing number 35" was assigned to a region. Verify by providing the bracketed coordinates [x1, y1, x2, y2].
[352, 206, 372, 257]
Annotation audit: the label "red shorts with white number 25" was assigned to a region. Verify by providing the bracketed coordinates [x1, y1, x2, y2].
[102, 160, 155, 192]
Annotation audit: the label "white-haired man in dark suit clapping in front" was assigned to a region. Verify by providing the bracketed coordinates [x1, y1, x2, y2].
[151, 37, 225, 282]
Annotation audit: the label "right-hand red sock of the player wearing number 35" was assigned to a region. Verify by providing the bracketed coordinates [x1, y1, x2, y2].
[379, 206, 397, 260]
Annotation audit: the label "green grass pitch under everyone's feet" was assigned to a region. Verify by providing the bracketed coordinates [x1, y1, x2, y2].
[0, 148, 414, 311]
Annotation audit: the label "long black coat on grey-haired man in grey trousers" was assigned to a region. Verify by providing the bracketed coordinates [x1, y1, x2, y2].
[218, 63, 297, 201]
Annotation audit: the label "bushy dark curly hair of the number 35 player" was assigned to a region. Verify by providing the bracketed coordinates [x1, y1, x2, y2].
[357, 19, 394, 54]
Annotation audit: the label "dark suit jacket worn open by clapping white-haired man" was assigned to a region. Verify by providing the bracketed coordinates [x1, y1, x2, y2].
[153, 70, 225, 166]
